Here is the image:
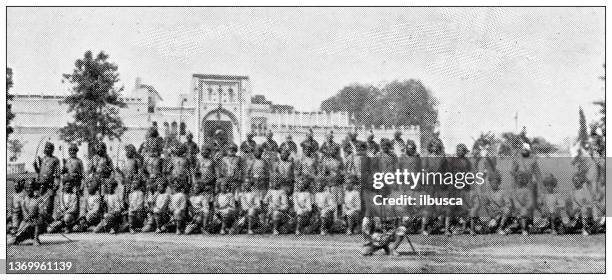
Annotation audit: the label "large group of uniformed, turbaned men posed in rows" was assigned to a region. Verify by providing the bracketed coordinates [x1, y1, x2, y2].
[8, 127, 605, 255]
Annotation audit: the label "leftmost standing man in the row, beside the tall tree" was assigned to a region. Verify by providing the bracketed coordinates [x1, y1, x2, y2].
[34, 142, 61, 220]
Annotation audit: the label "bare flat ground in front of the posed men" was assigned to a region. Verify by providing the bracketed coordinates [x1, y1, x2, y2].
[7, 233, 605, 273]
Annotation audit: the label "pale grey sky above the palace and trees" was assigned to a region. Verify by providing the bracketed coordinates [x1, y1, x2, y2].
[7, 8, 604, 145]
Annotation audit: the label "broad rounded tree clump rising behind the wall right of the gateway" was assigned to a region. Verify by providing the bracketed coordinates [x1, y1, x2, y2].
[321, 79, 438, 147]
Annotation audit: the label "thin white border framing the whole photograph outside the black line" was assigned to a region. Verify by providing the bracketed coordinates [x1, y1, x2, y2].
[0, 0, 612, 280]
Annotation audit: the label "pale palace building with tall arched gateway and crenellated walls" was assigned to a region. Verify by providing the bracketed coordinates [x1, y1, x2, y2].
[7, 74, 420, 170]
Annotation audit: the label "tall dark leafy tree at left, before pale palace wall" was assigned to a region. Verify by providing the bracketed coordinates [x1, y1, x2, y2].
[60, 51, 126, 155]
